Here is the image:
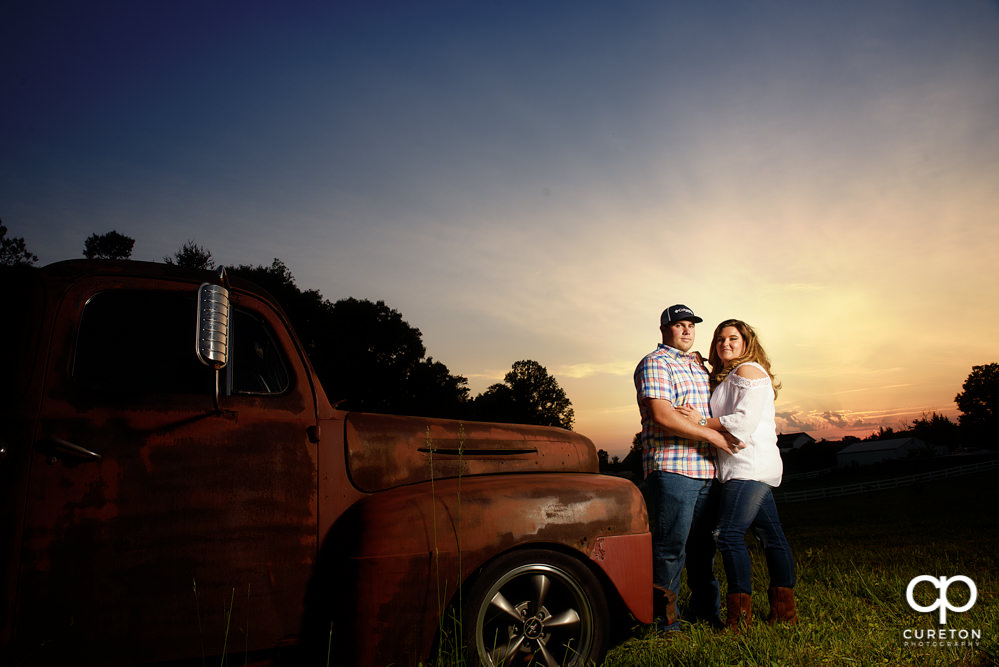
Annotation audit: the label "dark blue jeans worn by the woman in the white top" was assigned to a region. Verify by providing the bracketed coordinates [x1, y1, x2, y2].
[715, 479, 795, 594]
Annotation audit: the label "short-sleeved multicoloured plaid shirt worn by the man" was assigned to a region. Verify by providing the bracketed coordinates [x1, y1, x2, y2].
[635, 343, 715, 479]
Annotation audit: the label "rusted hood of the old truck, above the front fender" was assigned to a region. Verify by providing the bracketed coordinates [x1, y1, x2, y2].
[344, 413, 598, 492]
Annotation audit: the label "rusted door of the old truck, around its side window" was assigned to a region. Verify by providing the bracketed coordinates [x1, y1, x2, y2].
[5, 264, 317, 665]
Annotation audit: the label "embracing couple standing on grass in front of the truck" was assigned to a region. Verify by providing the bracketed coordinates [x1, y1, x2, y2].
[635, 304, 797, 631]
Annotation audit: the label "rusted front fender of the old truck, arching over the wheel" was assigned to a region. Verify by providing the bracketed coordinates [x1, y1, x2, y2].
[321, 474, 651, 665]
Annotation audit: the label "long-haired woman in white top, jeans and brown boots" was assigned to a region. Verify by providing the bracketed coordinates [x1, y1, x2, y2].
[677, 320, 798, 629]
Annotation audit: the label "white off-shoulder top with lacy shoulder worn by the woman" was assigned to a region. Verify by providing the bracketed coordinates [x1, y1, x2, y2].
[711, 362, 784, 486]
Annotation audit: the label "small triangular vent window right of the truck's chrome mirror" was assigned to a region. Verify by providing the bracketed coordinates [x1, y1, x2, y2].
[231, 308, 291, 395]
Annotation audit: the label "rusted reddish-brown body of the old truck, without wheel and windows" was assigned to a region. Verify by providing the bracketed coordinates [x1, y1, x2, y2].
[0, 262, 651, 665]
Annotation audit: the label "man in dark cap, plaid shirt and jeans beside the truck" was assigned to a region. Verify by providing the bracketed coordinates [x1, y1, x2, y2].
[635, 304, 735, 631]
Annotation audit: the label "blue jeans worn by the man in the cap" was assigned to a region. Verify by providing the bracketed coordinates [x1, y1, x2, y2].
[645, 471, 720, 619]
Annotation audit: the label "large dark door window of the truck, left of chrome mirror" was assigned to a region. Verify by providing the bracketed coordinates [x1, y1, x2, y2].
[73, 290, 214, 397]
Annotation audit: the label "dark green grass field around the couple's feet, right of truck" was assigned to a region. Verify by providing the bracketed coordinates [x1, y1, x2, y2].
[604, 473, 999, 667]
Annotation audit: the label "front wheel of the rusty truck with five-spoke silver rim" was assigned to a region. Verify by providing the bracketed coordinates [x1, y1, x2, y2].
[463, 549, 608, 667]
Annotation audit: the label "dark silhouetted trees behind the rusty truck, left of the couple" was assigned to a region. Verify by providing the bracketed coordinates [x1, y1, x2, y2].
[0, 223, 575, 429]
